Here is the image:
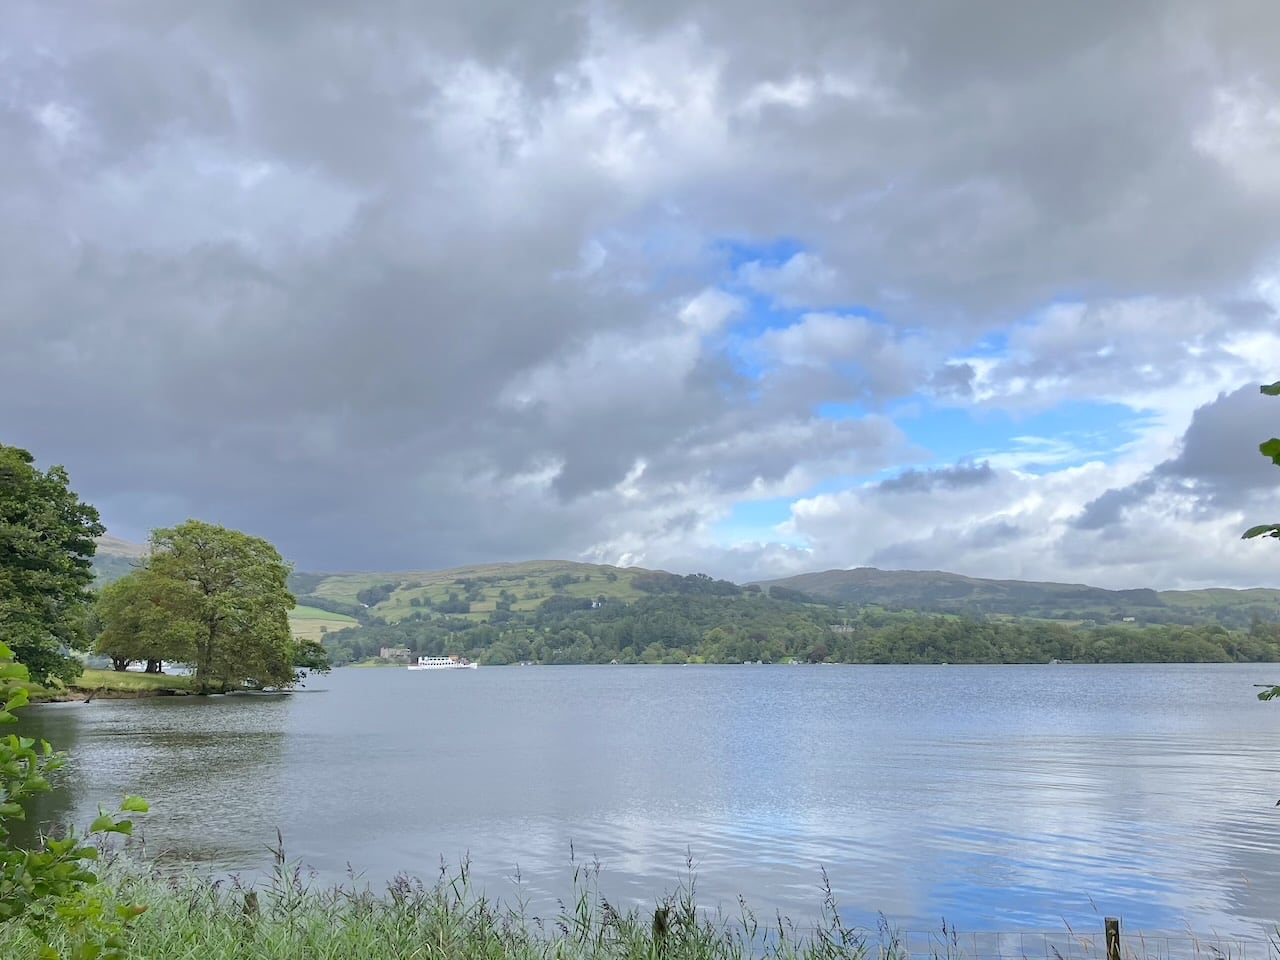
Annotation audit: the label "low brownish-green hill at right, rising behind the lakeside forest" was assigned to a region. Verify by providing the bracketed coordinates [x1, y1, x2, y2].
[759, 567, 1280, 627]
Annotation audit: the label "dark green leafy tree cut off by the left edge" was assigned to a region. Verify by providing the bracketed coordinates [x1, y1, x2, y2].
[0, 444, 105, 682]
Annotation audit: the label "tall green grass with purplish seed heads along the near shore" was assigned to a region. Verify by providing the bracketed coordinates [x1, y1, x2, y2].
[0, 850, 908, 960]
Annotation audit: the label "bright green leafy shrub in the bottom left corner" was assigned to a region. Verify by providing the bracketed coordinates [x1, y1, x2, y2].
[0, 643, 147, 960]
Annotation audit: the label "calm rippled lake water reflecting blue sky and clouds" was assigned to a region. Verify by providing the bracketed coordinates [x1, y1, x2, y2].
[15, 664, 1280, 937]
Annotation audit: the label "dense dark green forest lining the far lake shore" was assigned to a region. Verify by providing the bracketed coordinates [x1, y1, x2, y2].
[317, 586, 1280, 664]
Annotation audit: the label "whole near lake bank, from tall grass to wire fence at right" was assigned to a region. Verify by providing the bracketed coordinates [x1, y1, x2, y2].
[0, 852, 1239, 960]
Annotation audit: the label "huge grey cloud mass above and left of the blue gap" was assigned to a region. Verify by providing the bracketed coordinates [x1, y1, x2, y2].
[0, 0, 1280, 568]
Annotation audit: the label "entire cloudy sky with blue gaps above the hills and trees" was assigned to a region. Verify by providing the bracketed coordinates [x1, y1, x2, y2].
[0, 0, 1280, 588]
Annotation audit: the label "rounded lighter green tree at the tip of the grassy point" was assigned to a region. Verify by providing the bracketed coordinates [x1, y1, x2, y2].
[132, 520, 325, 690]
